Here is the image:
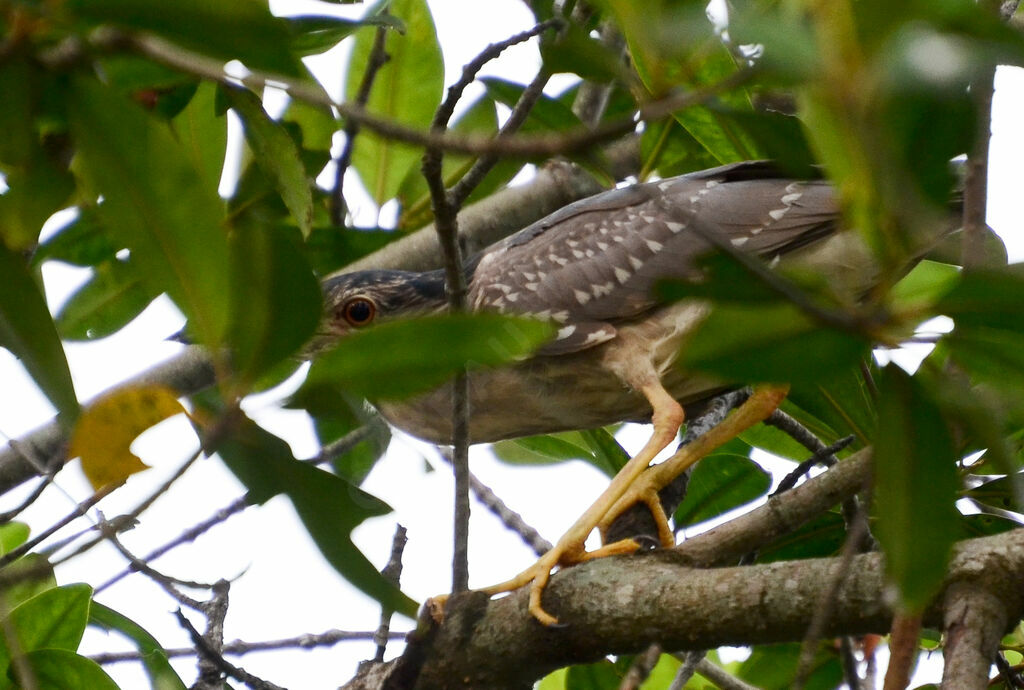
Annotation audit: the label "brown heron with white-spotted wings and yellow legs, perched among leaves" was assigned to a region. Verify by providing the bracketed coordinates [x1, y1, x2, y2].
[324, 162, 933, 623]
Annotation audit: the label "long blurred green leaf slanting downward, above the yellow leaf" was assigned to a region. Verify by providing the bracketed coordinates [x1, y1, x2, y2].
[69, 75, 237, 346]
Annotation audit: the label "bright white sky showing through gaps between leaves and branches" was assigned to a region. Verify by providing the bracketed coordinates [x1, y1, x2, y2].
[0, 0, 1024, 690]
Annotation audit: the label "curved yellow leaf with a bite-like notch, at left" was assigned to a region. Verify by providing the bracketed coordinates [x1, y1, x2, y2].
[69, 386, 185, 490]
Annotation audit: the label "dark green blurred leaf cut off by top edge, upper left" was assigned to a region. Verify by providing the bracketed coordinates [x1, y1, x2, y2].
[68, 0, 302, 77]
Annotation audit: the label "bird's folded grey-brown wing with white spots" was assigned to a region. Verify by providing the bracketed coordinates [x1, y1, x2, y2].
[469, 163, 839, 341]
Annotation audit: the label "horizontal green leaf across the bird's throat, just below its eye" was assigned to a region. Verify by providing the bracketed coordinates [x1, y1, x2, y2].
[305, 313, 553, 399]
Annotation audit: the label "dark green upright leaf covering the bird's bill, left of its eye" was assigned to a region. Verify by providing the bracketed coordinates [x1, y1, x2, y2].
[229, 223, 322, 385]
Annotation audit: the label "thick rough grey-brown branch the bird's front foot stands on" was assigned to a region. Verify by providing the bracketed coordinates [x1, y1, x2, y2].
[350, 530, 1024, 690]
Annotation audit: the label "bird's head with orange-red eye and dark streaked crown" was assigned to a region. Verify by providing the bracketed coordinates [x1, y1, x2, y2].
[306, 270, 446, 355]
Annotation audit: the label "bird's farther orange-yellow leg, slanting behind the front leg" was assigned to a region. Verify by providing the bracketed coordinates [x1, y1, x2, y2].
[598, 386, 790, 536]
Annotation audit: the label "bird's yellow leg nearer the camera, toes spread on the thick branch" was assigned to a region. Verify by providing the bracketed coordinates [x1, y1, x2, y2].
[468, 380, 683, 626]
